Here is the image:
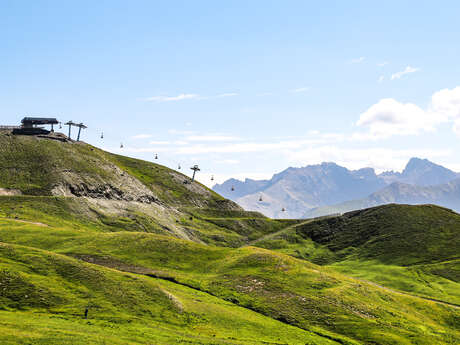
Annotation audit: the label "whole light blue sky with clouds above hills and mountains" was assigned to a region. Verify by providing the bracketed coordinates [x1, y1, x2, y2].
[0, 0, 460, 184]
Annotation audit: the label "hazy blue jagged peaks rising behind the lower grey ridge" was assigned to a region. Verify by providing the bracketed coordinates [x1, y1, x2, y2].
[214, 157, 460, 218]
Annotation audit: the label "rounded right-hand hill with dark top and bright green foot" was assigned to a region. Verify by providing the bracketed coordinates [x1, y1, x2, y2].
[253, 205, 460, 304]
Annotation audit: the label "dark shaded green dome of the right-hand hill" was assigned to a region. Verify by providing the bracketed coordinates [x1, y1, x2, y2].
[296, 205, 460, 266]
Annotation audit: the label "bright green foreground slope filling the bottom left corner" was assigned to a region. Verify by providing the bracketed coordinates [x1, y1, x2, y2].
[0, 244, 333, 344]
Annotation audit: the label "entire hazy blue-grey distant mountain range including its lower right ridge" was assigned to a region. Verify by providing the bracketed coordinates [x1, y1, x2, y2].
[213, 158, 460, 218]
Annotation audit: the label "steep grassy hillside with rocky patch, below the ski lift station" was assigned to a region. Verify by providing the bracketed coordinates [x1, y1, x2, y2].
[0, 131, 292, 247]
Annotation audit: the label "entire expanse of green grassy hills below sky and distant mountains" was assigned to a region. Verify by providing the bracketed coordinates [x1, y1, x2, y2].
[0, 132, 460, 345]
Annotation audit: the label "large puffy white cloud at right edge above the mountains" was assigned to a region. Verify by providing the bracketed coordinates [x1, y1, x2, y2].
[355, 86, 460, 139]
